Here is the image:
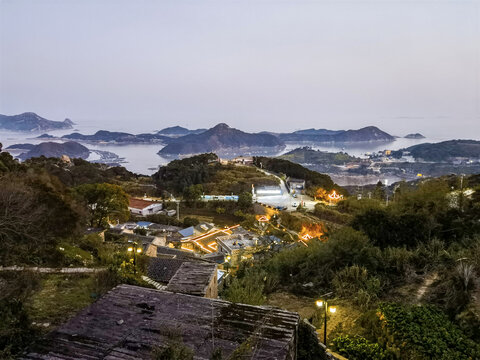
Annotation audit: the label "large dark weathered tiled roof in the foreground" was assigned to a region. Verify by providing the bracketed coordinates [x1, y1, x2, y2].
[23, 285, 299, 360]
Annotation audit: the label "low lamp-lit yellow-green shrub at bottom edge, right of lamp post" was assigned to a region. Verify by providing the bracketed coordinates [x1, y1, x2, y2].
[333, 335, 391, 360]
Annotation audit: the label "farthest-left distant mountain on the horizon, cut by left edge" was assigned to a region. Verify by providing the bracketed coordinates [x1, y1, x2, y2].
[0, 112, 74, 132]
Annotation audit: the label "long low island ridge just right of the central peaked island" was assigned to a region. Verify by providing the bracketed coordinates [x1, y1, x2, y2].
[278, 126, 395, 143]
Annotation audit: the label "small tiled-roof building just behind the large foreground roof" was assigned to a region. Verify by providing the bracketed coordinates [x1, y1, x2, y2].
[167, 261, 218, 299]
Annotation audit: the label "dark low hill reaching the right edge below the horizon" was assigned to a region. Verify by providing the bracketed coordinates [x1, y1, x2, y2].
[393, 140, 480, 162]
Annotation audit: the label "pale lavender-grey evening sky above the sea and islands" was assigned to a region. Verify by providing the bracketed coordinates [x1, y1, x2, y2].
[0, 0, 480, 139]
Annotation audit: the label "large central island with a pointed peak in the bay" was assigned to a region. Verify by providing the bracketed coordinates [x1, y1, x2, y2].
[158, 123, 285, 155]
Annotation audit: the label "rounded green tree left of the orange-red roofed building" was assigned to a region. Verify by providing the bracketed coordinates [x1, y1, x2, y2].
[75, 183, 129, 227]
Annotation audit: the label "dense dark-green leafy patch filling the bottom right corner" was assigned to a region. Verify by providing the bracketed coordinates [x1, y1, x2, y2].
[378, 303, 480, 360]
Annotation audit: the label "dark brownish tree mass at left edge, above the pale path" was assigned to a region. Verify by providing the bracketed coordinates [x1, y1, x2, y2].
[0, 172, 83, 265]
